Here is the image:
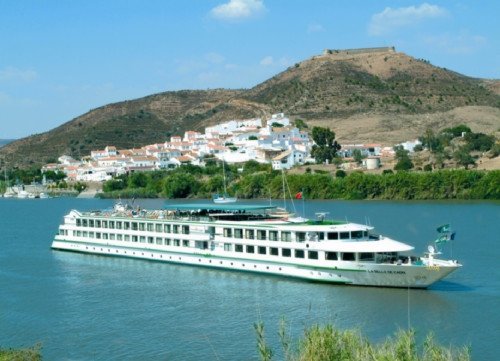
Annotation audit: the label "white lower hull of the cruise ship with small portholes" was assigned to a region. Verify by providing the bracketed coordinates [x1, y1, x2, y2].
[52, 236, 459, 288]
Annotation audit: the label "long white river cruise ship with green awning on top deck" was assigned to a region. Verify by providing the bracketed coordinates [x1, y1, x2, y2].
[52, 203, 461, 288]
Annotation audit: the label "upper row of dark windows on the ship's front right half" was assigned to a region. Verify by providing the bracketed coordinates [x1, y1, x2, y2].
[223, 228, 368, 242]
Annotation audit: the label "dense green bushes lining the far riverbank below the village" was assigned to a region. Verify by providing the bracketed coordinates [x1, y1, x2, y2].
[99, 161, 500, 200]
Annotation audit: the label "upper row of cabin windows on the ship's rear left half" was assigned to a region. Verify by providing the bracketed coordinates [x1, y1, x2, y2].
[76, 218, 189, 234]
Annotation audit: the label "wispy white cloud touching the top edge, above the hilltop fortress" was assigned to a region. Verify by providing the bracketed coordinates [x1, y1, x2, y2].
[368, 3, 448, 36]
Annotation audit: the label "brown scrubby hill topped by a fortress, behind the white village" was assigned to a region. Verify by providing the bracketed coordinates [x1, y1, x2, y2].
[0, 48, 500, 166]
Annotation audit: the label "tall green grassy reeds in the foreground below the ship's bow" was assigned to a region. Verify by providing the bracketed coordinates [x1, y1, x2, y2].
[255, 321, 471, 361]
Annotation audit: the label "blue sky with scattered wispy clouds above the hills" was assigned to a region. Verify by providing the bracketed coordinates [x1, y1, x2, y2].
[0, 0, 500, 139]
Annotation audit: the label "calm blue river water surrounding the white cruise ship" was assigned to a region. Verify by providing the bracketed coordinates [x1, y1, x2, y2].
[0, 198, 500, 360]
